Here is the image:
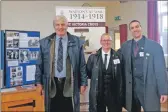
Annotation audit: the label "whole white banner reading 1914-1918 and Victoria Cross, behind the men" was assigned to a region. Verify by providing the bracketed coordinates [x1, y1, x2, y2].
[56, 6, 106, 111]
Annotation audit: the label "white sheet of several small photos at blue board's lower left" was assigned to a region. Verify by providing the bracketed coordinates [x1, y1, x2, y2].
[10, 66, 23, 86]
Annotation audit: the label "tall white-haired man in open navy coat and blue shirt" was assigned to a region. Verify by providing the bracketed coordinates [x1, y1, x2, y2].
[35, 15, 87, 112]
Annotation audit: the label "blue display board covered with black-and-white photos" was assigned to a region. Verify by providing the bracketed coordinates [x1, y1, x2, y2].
[5, 30, 40, 88]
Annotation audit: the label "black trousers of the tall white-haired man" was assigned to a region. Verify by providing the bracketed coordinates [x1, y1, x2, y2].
[50, 78, 73, 112]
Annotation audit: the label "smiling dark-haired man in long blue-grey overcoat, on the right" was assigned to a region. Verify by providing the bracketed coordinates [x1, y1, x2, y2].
[118, 20, 168, 112]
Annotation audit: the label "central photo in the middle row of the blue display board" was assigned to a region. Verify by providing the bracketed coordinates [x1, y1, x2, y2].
[19, 49, 29, 63]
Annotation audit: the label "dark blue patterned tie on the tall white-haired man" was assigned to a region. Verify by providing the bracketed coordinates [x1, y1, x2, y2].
[57, 38, 63, 72]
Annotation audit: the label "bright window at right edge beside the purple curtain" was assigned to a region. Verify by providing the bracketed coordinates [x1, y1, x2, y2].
[158, 1, 168, 56]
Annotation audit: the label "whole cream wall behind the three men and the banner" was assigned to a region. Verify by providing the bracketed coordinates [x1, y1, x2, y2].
[1, 1, 147, 38]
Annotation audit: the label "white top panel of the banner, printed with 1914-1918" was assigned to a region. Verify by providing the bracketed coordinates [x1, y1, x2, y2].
[56, 6, 105, 22]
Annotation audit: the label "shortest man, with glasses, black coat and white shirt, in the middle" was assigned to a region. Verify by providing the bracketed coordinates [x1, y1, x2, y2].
[86, 33, 123, 112]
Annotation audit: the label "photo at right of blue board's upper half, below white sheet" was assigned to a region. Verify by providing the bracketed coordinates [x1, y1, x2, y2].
[28, 37, 40, 48]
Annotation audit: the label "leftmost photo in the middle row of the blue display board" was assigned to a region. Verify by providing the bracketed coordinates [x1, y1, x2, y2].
[6, 49, 19, 60]
